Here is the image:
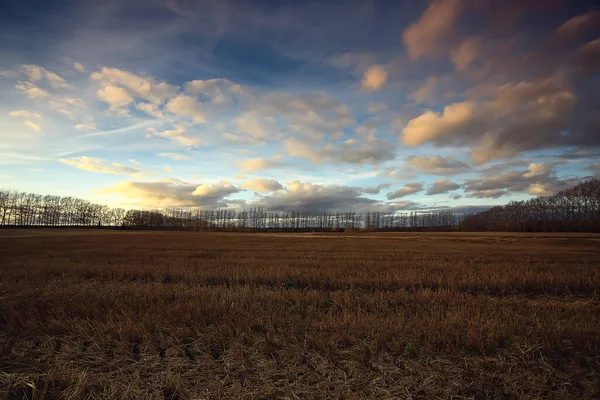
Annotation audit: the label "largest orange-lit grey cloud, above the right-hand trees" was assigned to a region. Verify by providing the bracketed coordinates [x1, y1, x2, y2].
[402, 75, 580, 164]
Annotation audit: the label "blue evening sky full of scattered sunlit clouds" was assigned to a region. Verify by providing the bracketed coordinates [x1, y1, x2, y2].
[0, 0, 600, 212]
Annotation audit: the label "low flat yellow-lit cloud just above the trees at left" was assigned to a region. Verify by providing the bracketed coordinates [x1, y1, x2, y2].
[97, 179, 240, 209]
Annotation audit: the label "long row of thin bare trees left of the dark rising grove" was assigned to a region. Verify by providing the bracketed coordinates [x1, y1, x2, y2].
[0, 190, 458, 232]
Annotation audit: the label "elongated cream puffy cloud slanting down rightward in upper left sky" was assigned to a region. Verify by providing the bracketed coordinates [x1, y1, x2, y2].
[90, 67, 177, 104]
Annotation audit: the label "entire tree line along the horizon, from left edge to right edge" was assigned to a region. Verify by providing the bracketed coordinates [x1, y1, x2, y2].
[0, 179, 600, 232]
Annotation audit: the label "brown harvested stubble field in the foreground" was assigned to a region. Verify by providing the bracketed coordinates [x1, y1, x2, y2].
[0, 230, 600, 400]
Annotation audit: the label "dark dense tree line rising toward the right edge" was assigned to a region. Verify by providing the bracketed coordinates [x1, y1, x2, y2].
[461, 179, 600, 232]
